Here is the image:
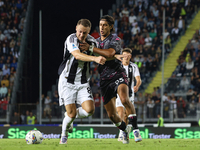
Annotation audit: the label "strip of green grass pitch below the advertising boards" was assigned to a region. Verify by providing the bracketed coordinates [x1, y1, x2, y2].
[0, 139, 200, 150]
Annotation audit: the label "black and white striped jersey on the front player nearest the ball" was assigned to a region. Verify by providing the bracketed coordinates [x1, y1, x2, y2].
[58, 33, 97, 84]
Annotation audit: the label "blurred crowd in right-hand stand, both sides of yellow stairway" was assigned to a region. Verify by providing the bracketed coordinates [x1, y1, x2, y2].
[90, 0, 200, 118]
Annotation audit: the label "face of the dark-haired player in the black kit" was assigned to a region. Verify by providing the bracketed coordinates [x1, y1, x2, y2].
[99, 20, 113, 37]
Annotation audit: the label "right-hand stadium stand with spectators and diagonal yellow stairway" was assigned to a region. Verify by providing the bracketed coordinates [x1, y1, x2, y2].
[40, 0, 200, 123]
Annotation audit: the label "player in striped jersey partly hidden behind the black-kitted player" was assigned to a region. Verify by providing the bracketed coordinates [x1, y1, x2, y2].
[116, 48, 142, 141]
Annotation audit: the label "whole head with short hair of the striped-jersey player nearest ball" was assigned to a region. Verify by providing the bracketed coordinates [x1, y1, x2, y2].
[76, 19, 91, 42]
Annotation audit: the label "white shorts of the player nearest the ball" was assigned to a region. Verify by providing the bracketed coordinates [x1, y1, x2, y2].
[58, 75, 94, 106]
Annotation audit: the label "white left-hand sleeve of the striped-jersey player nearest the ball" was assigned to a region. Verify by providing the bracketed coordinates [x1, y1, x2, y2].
[65, 35, 79, 53]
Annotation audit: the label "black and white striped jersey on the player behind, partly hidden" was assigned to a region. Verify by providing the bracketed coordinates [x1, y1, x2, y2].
[123, 62, 140, 97]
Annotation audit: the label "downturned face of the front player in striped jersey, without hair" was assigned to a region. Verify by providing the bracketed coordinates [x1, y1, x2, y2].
[76, 24, 90, 42]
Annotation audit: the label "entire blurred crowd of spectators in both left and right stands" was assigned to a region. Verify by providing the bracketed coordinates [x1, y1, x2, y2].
[0, 0, 200, 121]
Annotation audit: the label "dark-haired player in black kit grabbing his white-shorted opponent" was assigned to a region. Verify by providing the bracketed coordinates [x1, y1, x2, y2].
[81, 15, 142, 144]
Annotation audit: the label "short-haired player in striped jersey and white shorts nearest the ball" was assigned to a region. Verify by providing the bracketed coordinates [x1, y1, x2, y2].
[58, 19, 106, 144]
